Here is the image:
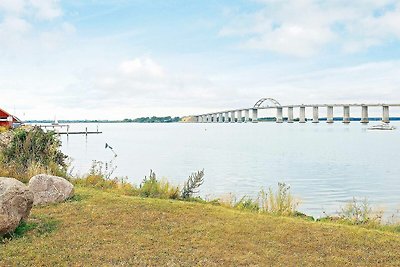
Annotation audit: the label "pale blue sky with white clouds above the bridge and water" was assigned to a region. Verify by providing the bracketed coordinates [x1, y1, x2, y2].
[0, 0, 400, 119]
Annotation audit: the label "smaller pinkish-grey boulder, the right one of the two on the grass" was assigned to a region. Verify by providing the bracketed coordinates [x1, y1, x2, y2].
[29, 174, 74, 205]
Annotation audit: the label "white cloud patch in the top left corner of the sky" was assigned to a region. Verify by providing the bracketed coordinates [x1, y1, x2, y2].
[0, 0, 76, 55]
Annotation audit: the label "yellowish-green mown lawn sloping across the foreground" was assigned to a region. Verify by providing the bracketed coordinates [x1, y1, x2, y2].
[0, 187, 400, 266]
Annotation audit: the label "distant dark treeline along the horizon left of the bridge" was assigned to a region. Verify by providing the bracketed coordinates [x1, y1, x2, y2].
[25, 116, 181, 124]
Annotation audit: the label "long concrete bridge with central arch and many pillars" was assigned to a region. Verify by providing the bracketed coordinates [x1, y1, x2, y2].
[191, 98, 400, 123]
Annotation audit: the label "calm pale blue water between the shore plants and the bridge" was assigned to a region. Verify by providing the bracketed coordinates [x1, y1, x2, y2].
[62, 122, 400, 217]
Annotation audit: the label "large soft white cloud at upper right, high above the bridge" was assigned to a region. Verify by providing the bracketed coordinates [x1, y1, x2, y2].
[220, 0, 400, 56]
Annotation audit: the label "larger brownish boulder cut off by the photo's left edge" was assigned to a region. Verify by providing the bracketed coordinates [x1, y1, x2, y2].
[0, 177, 33, 236]
